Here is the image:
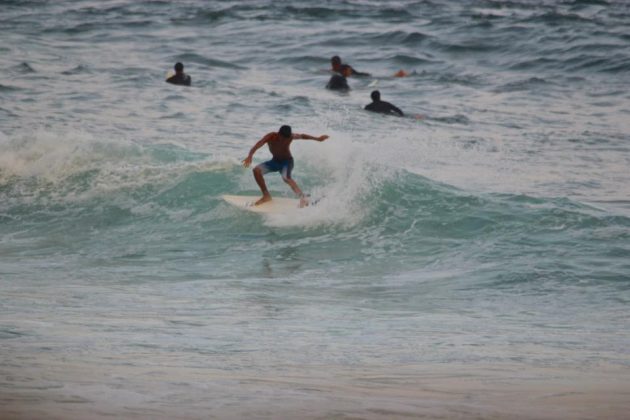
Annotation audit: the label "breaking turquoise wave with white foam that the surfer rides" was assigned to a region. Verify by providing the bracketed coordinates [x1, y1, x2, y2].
[0, 132, 630, 293]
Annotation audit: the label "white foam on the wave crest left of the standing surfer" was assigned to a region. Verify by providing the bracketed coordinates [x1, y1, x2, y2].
[0, 129, 235, 206]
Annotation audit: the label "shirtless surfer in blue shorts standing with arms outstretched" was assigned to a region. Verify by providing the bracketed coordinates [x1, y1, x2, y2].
[243, 125, 328, 207]
